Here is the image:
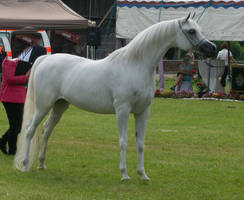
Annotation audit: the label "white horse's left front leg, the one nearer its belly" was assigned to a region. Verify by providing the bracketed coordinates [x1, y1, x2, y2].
[115, 105, 130, 181]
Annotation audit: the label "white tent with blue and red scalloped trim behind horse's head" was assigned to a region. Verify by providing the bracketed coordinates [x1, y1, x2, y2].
[116, 0, 244, 41]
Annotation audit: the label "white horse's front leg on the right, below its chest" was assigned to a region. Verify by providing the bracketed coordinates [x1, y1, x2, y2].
[134, 106, 150, 180]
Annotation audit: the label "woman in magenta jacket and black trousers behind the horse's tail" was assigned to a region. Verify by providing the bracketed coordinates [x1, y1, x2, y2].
[0, 58, 30, 155]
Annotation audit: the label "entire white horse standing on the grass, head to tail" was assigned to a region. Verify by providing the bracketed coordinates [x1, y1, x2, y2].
[15, 16, 215, 180]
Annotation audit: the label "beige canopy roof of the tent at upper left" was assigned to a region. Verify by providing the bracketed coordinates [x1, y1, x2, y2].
[0, 0, 88, 30]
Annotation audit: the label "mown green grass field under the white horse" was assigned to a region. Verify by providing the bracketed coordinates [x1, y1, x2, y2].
[0, 94, 244, 200]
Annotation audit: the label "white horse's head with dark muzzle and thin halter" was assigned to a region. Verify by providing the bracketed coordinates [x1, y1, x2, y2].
[176, 14, 216, 57]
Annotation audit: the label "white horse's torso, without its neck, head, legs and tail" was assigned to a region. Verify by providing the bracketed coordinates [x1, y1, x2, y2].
[34, 54, 154, 114]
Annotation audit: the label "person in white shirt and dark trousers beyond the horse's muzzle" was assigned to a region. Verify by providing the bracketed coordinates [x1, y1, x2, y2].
[217, 42, 237, 87]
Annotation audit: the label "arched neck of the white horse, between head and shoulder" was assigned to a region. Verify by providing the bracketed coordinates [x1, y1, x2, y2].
[127, 21, 176, 72]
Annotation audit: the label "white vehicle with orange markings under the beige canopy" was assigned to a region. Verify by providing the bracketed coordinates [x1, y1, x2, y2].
[0, 29, 51, 58]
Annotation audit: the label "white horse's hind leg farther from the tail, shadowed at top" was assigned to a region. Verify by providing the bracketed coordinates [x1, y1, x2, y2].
[38, 100, 69, 169]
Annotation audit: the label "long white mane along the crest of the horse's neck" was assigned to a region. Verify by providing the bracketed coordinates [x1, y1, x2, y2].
[107, 20, 177, 62]
